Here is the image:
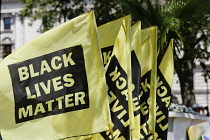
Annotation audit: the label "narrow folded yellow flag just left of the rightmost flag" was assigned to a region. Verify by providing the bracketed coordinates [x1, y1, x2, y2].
[140, 27, 157, 139]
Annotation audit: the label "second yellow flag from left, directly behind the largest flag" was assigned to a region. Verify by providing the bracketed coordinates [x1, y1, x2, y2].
[93, 16, 133, 140]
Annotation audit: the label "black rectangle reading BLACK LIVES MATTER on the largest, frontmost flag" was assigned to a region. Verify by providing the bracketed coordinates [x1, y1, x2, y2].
[8, 45, 89, 123]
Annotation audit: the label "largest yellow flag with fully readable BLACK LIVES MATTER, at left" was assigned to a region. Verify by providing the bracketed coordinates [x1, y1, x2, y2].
[0, 12, 109, 140]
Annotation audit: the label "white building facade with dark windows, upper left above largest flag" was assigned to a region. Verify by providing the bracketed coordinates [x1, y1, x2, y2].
[0, 0, 41, 60]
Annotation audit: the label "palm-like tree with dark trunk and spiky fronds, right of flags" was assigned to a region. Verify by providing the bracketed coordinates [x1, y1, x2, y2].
[120, 0, 210, 106]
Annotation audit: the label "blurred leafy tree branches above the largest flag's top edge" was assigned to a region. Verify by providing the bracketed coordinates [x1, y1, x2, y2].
[21, 0, 125, 32]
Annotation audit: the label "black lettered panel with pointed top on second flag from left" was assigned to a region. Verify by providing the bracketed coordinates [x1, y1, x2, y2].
[101, 55, 130, 140]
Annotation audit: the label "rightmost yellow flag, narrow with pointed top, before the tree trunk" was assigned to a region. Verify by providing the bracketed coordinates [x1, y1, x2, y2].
[155, 40, 174, 140]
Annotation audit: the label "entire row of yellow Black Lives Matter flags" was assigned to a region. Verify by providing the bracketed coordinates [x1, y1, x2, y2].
[0, 11, 173, 140]
